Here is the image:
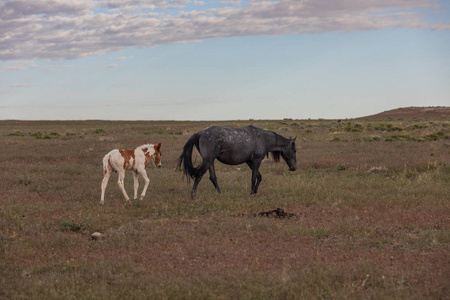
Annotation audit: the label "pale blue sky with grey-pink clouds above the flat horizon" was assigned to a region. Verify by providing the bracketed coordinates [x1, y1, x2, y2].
[0, 0, 450, 120]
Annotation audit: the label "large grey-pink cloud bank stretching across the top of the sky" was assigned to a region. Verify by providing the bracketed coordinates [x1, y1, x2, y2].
[0, 0, 450, 60]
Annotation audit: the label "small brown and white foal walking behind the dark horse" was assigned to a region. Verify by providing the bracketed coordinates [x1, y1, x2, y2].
[100, 143, 161, 204]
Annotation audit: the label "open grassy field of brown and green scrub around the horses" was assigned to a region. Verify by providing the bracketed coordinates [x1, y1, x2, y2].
[0, 113, 450, 299]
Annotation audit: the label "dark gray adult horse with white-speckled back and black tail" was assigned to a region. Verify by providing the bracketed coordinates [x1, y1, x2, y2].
[178, 126, 297, 197]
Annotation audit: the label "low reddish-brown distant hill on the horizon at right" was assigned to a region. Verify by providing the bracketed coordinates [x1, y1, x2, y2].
[359, 106, 450, 120]
